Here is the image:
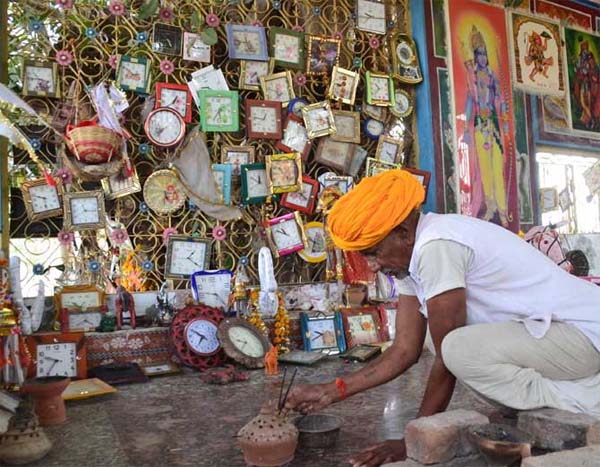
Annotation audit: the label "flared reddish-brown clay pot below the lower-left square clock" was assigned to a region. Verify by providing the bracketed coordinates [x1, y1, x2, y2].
[22, 377, 71, 426]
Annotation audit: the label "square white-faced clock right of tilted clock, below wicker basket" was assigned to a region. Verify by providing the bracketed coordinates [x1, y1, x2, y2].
[63, 190, 106, 230]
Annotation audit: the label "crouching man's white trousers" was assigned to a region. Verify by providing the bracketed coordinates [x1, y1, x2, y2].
[442, 321, 600, 417]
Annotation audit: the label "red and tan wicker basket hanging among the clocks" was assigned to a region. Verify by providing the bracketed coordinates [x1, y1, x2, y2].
[65, 121, 122, 165]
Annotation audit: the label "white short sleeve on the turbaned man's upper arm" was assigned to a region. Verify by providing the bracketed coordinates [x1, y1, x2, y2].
[417, 240, 473, 301]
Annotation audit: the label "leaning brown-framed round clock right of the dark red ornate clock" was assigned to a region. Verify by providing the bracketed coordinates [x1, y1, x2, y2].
[218, 318, 271, 368]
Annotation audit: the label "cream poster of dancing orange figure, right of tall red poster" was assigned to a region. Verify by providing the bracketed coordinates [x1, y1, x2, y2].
[508, 11, 565, 94]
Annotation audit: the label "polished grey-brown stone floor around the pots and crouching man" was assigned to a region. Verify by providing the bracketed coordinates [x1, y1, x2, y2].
[25, 353, 490, 467]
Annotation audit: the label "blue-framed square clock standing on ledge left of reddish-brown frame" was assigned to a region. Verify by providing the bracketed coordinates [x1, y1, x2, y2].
[300, 311, 346, 355]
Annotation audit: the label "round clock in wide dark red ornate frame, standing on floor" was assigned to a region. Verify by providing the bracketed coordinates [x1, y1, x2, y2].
[171, 305, 225, 370]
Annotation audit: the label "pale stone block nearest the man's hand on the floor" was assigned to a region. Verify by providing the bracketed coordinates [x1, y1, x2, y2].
[404, 410, 489, 464]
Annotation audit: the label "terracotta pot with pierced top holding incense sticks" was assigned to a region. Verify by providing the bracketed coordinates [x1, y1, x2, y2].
[238, 408, 298, 467]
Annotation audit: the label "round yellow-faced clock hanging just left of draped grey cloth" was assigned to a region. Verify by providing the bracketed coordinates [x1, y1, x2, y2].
[144, 169, 186, 214]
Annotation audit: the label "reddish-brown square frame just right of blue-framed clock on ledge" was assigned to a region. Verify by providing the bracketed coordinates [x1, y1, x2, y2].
[340, 306, 385, 349]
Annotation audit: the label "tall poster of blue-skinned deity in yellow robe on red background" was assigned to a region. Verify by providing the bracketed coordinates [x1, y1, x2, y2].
[447, 0, 519, 232]
